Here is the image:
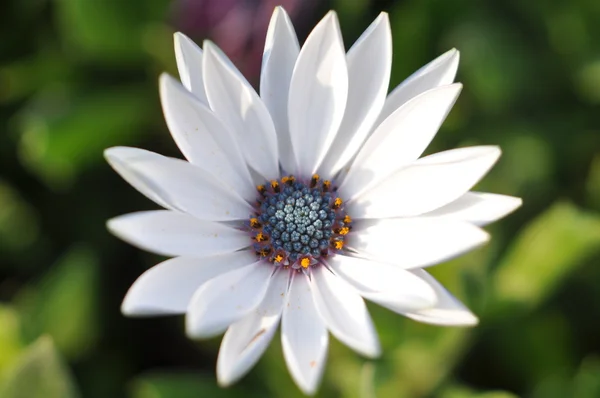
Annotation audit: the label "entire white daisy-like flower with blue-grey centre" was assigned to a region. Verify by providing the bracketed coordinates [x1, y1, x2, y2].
[105, 8, 521, 394]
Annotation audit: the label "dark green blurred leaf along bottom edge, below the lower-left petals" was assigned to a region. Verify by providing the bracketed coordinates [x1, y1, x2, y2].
[130, 373, 259, 398]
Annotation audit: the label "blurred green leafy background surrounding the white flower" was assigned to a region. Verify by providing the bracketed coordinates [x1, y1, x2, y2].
[0, 0, 600, 398]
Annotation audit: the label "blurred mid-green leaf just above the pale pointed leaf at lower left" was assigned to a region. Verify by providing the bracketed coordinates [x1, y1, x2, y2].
[17, 247, 99, 359]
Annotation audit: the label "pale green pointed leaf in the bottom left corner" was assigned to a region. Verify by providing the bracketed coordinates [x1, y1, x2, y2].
[0, 337, 79, 398]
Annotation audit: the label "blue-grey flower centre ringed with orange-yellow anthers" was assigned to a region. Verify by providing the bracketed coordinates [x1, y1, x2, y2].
[248, 174, 352, 270]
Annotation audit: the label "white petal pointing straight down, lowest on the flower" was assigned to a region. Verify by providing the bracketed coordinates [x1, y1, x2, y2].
[281, 274, 329, 395]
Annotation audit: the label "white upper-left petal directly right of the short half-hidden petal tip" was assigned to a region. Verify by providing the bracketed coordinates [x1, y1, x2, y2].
[203, 41, 279, 179]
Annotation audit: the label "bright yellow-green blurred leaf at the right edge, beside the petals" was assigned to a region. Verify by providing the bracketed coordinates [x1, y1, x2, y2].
[493, 202, 600, 318]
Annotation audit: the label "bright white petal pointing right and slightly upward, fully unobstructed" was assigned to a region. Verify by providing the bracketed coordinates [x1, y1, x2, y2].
[346, 146, 500, 219]
